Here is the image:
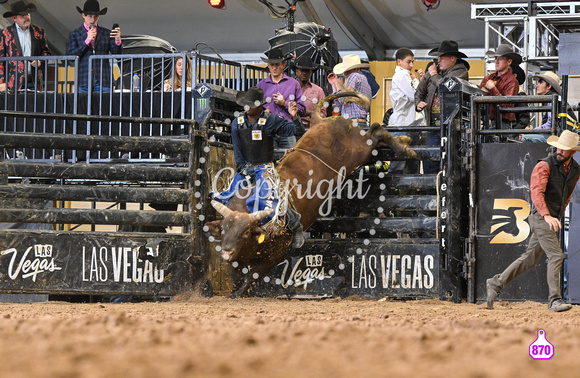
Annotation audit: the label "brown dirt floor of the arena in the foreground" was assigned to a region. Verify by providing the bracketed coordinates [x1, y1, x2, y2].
[0, 297, 580, 377]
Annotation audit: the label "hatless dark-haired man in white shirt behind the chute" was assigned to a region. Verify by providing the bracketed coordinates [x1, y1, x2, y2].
[389, 47, 425, 174]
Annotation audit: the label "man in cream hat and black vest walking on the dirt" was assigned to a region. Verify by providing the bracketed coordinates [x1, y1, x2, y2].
[486, 130, 580, 312]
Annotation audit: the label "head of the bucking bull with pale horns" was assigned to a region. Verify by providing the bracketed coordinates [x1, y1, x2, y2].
[205, 201, 274, 261]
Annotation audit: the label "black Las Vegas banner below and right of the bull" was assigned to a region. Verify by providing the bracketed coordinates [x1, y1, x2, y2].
[256, 239, 439, 298]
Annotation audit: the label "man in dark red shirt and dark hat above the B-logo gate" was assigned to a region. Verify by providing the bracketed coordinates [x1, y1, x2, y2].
[480, 44, 522, 129]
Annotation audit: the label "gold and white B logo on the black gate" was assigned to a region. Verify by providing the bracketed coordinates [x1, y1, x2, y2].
[489, 198, 530, 244]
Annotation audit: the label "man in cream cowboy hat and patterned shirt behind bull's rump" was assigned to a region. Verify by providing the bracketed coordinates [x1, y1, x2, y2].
[328, 54, 373, 128]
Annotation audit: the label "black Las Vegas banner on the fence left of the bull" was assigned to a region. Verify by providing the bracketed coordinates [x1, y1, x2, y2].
[0, 231, 192, 296]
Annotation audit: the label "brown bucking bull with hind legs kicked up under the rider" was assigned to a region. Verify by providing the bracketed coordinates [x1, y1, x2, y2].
[206, 92, 417, 297]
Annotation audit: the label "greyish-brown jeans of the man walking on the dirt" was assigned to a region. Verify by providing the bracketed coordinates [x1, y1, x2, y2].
[489, 211, 564, 305]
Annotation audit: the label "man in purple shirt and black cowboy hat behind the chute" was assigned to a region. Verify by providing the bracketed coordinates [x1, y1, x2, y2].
[257, 49, 306, 148]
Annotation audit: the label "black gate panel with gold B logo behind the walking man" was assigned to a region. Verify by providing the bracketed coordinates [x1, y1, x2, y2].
[475, 143, 550, 302]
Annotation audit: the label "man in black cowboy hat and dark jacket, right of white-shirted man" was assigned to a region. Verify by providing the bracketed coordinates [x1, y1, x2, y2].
[415, 40, 469, 173]
